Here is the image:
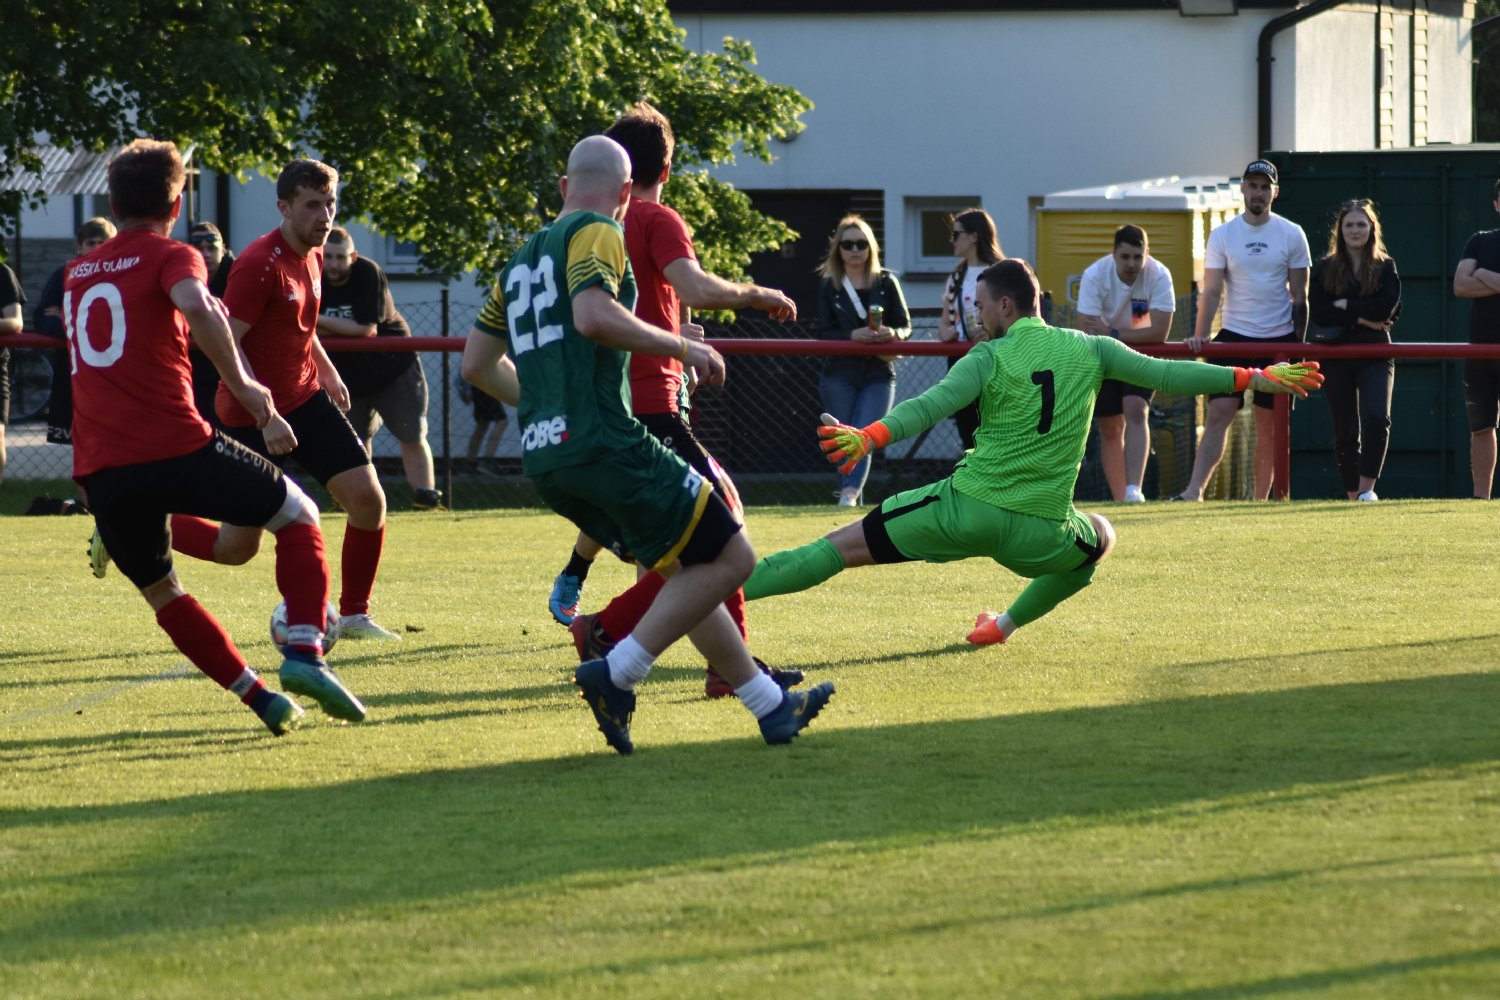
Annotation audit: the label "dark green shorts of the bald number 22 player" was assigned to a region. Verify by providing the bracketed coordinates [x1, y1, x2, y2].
[531, 438, 714, 570]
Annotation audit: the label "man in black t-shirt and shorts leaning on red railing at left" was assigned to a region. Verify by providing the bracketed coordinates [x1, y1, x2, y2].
[318, 226, 443, 510]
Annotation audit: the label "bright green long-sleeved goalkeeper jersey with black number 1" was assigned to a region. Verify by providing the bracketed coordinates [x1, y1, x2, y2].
[881, 316, 1235, 520]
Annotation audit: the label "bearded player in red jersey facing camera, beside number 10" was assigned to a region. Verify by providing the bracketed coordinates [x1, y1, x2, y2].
[162, 159, 401, 639]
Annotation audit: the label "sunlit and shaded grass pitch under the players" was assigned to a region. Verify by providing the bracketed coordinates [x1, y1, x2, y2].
[0, 501, 1500, 1000]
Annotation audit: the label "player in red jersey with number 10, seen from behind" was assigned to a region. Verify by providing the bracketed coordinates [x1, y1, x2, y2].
[63, 139, 365, 736]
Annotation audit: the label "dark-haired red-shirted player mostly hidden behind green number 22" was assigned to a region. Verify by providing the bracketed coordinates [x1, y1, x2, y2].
[548, 102, 803, 697]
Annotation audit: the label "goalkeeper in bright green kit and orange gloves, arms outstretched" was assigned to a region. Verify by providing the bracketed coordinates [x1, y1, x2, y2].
[744, 258, 1323, 646]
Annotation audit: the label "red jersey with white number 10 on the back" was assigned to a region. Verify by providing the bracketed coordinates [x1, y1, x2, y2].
[63, 229, 213, 478]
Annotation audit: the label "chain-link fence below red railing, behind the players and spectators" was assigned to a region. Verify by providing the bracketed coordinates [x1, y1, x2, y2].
[6, 298, 1253, 510]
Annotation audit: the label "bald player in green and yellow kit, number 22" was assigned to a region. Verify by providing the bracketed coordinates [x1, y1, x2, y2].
[462, 135, 834, 754]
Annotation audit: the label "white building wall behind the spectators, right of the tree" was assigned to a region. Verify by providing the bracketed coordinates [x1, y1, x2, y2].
[675, 4, 1470, 306]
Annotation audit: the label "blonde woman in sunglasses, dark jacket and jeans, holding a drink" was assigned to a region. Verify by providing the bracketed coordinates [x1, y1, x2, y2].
[818, 216, 912, 507]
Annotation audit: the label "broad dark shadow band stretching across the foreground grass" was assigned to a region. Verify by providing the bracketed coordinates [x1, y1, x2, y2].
[0, 673, 1500, 971]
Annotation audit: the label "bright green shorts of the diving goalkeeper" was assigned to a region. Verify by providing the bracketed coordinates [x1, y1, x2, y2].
[864, 478, 1100, 577]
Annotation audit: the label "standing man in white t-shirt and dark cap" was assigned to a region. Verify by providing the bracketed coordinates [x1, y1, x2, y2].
[1173, 160, 1313, 501]
